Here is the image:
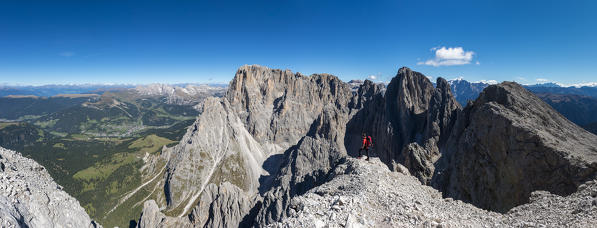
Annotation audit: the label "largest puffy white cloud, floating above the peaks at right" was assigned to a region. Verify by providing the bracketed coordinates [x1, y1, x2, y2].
[417, 47, 480, 67]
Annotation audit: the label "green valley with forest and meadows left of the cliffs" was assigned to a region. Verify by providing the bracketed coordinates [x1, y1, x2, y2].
[0, 86, 218, 227]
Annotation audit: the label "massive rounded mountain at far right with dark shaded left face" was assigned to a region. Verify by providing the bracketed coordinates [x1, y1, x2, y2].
[433, 82, 597, 211]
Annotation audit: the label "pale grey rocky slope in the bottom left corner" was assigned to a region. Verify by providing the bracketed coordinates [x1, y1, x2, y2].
[0, 148, 100, 227]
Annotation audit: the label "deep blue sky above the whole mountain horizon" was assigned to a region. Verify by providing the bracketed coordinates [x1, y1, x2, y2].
[0, 0, 597, 85]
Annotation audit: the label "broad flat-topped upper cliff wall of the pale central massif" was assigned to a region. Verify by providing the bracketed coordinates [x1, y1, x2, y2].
[226, 66, 352, 149]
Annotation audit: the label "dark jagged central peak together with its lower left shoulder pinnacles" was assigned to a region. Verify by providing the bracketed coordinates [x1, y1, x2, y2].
[345, 67, 461, 183]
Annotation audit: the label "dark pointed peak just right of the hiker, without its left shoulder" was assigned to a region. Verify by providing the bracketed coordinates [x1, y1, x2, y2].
[369, 67, 461, 183]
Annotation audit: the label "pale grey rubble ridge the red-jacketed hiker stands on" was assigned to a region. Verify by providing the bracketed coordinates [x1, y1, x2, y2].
[269, 158, 597, 227]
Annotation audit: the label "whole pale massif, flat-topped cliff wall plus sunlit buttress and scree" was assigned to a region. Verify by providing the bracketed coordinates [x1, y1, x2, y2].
[139, 66, 360, 227]
